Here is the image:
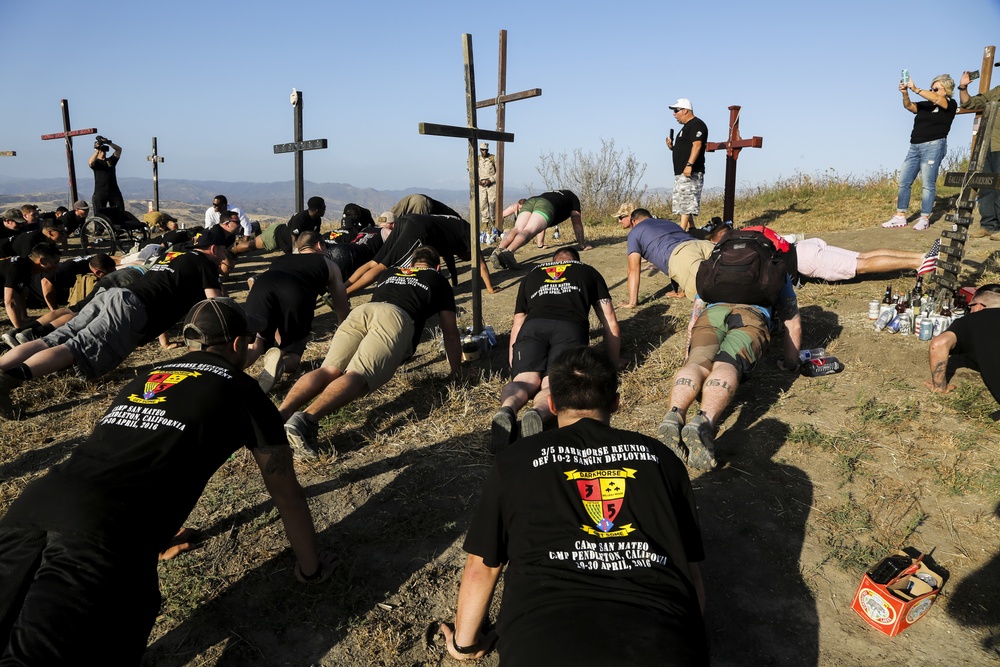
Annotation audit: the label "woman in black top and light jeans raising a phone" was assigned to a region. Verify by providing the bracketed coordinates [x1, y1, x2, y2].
[882, 74, 958, 232]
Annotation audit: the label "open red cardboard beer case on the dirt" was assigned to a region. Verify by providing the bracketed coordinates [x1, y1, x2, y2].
[851, 551, 944, 637]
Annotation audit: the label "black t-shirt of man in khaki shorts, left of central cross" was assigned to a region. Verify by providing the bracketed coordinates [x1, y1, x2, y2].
[372, 268, 455, 350]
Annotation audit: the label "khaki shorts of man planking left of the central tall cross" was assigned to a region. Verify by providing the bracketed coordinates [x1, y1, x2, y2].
[323, 301, 414, 391]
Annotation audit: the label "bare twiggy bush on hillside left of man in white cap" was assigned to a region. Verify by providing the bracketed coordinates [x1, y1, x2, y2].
[537, 139, 646, 219]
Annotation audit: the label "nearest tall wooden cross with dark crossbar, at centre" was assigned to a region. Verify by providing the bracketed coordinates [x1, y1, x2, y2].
[417, 33, 514, 333]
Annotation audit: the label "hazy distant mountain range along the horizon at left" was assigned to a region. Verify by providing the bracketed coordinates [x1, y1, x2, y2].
[0, 176, 531, 218]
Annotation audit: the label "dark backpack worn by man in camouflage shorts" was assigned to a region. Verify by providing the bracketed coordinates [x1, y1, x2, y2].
[695, 231, 788, 307]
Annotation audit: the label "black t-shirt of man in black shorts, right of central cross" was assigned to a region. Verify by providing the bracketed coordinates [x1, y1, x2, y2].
[514, 262, 611, 331]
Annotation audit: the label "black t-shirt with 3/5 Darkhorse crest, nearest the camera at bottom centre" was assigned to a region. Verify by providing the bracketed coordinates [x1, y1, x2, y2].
[463, 419, 704, 664]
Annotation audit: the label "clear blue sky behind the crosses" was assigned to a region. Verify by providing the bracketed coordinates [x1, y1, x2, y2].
[0, 0, 1000, 195]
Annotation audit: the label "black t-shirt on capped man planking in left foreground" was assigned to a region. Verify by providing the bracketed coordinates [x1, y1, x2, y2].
[3, 352, 287, 550]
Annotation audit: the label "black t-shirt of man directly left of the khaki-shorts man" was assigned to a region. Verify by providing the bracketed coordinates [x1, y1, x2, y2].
[245, 271, 317, 355]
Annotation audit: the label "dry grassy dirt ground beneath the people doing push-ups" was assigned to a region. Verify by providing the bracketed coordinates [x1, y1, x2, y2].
[0, 223, 1000, 666]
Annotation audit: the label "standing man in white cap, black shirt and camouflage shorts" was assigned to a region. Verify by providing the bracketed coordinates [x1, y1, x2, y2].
[667, 97, 708, 231]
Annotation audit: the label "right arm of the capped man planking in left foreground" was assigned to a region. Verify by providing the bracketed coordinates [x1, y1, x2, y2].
[253, 443, 320, 577]
